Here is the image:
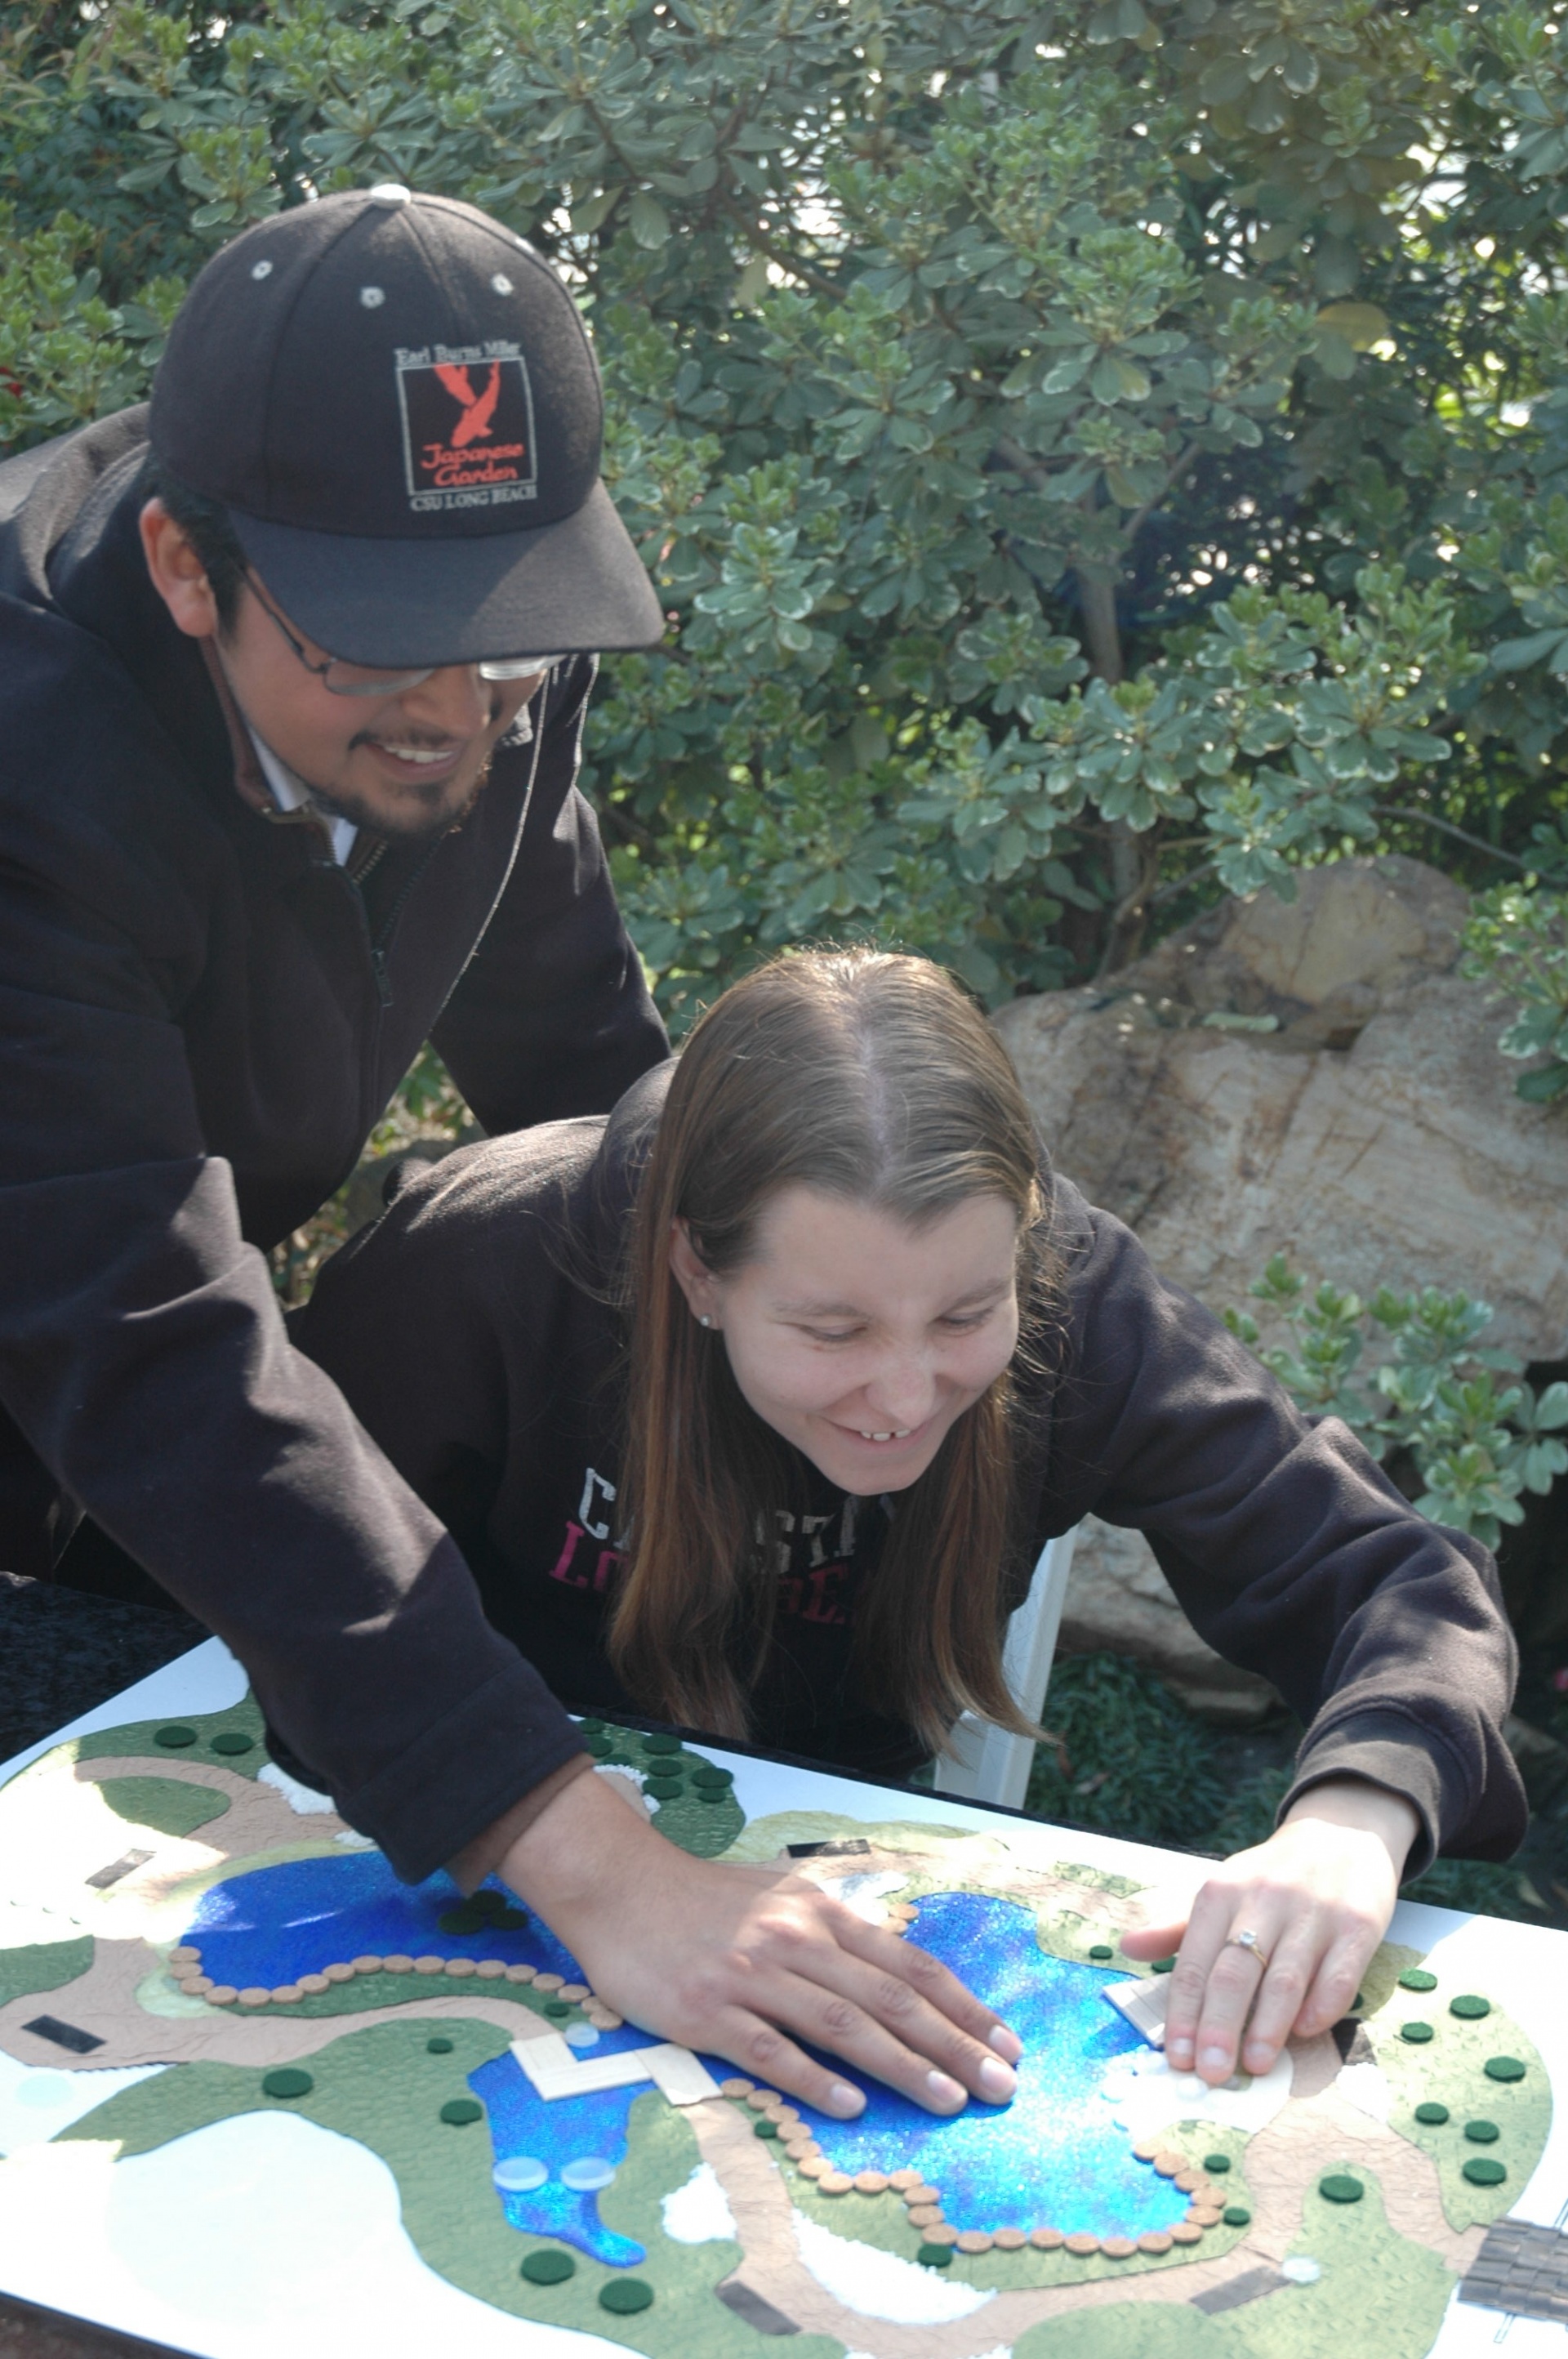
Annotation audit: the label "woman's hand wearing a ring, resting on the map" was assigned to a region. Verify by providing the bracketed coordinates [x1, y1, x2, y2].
[1122, 1779, 1419, 2085]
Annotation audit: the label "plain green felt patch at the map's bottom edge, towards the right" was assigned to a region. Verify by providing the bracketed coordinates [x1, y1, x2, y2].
[1012, 2175, 1453, 2359]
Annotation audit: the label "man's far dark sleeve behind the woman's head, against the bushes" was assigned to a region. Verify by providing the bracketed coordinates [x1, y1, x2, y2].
[431, 656, 670, 1135]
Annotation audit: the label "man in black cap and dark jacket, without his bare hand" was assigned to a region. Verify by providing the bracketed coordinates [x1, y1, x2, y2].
[0, 189, 665, 1878]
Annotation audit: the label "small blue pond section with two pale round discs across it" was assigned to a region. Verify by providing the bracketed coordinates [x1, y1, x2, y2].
[470, 2024, 653, 2269]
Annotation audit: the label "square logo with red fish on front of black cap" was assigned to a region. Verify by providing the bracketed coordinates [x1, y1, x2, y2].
[396, 342, 537, 515]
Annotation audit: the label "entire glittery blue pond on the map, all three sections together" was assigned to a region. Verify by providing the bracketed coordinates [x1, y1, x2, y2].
[184, 1852, 1186, 2267]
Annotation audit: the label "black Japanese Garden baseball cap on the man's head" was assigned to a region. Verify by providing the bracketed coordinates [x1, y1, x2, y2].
[151, 186, 662, 667]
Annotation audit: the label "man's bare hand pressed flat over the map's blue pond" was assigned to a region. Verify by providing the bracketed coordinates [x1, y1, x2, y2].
[500, 1774, 1021, 2118]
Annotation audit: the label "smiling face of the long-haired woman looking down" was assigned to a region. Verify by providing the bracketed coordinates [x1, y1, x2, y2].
[670, 1187, 1018, 1496]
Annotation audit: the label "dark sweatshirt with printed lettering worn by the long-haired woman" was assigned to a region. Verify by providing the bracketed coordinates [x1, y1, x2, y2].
[292, 1066, 1526, 1873]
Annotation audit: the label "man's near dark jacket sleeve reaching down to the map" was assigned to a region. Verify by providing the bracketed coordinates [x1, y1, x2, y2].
[0, 665, 580, 1878]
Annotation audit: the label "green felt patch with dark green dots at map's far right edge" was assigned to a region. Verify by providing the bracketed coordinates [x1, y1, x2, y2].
[1368, 1958, 1552, 2229]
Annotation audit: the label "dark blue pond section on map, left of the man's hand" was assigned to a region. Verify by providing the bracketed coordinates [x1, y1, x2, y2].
[181, 1852, 582, 1991]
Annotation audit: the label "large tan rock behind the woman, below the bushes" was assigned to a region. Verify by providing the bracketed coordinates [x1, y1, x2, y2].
[997, 854, 1568, 1701]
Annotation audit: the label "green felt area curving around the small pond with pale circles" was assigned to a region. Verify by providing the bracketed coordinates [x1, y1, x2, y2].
[64, 2017, 842, 2359]
